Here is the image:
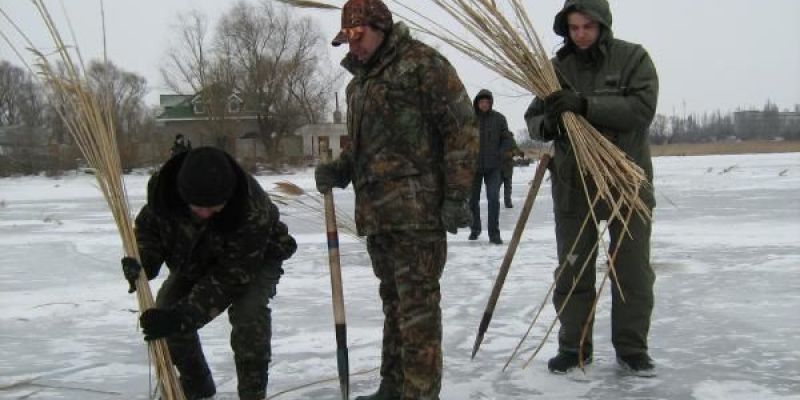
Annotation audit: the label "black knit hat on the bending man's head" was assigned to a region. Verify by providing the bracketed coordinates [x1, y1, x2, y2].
[178, 147, 236, 207]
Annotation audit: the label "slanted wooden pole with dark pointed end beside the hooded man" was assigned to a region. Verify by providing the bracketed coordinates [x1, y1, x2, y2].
[472, 153, 550, 359]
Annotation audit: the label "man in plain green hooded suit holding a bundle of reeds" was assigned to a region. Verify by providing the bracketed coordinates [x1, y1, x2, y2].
[525, 0, 658, 376]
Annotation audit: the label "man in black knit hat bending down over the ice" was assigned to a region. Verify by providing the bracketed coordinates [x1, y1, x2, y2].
[122, 147, 296, 400]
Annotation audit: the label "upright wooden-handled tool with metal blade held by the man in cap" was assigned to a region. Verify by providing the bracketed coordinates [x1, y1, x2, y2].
[321, 146, 350, 400]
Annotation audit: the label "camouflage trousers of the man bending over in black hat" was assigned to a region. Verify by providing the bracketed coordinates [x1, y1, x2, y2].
[156, 268, 275, 400]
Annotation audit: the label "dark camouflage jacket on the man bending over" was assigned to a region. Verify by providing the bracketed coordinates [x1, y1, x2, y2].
[135, 153, 296, 328]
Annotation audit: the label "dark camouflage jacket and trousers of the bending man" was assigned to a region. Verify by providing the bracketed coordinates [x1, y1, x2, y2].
[136, 151, 296, 399]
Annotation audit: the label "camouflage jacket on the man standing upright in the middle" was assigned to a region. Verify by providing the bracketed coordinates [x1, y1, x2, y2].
[334, 22, 478, 235]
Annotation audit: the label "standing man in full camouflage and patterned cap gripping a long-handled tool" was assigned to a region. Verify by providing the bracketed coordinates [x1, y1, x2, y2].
[315, 0, 478, 400]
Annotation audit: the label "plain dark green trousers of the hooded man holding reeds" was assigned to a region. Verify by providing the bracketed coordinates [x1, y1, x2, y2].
[553, 207, 656, 356]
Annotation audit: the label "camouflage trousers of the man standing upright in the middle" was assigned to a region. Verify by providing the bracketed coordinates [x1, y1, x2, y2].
[367, 231, 447, 400]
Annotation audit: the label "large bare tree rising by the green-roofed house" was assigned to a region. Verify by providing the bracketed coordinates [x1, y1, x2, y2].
[162, 0, 341, 160]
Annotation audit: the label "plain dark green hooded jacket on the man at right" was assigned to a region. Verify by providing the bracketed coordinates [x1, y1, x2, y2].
[525, 0, 658, 216]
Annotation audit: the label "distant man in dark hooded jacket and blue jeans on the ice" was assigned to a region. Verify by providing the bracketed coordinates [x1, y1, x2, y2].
[469, 89, 513, 244]
